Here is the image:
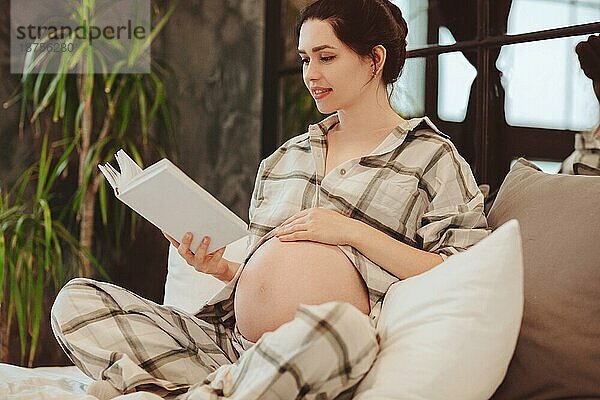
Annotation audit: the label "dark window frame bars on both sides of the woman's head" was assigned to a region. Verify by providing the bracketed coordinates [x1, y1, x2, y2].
[261, 0, 600, 189]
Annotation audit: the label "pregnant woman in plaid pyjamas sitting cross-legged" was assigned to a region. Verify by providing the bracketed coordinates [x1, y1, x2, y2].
[52, 0, 488, 400]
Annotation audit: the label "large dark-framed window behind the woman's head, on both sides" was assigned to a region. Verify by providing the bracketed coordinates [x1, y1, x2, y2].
[263, 0, 600, 188]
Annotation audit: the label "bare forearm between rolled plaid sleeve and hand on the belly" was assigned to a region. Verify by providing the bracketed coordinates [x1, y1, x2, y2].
[347, 219, 443, 279]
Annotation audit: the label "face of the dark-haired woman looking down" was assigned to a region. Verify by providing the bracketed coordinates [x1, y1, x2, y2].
[298, 19, 375, 114]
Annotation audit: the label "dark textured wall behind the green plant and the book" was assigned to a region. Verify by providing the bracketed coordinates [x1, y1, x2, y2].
[0, 0, 264, 365]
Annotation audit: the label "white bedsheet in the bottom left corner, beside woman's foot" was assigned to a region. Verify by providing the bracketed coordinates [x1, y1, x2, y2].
[0, 364, 162, 400]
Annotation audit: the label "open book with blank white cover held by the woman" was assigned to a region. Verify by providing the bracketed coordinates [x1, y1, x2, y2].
[98, 149, 247, 252]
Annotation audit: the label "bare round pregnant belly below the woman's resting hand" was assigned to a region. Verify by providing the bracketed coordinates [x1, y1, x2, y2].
[235, 238, 369, 342]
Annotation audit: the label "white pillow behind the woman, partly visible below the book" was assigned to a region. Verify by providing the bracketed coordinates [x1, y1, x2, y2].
[163, 237, 247, 314]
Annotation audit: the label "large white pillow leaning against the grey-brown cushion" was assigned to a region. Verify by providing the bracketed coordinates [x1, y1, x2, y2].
[355, 220, 523, 400]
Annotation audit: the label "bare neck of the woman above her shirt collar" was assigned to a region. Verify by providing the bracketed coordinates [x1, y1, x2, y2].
[338, 84, 403, 136]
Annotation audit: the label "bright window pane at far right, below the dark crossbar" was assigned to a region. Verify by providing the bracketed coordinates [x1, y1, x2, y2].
[496, 36, 598, 131]
